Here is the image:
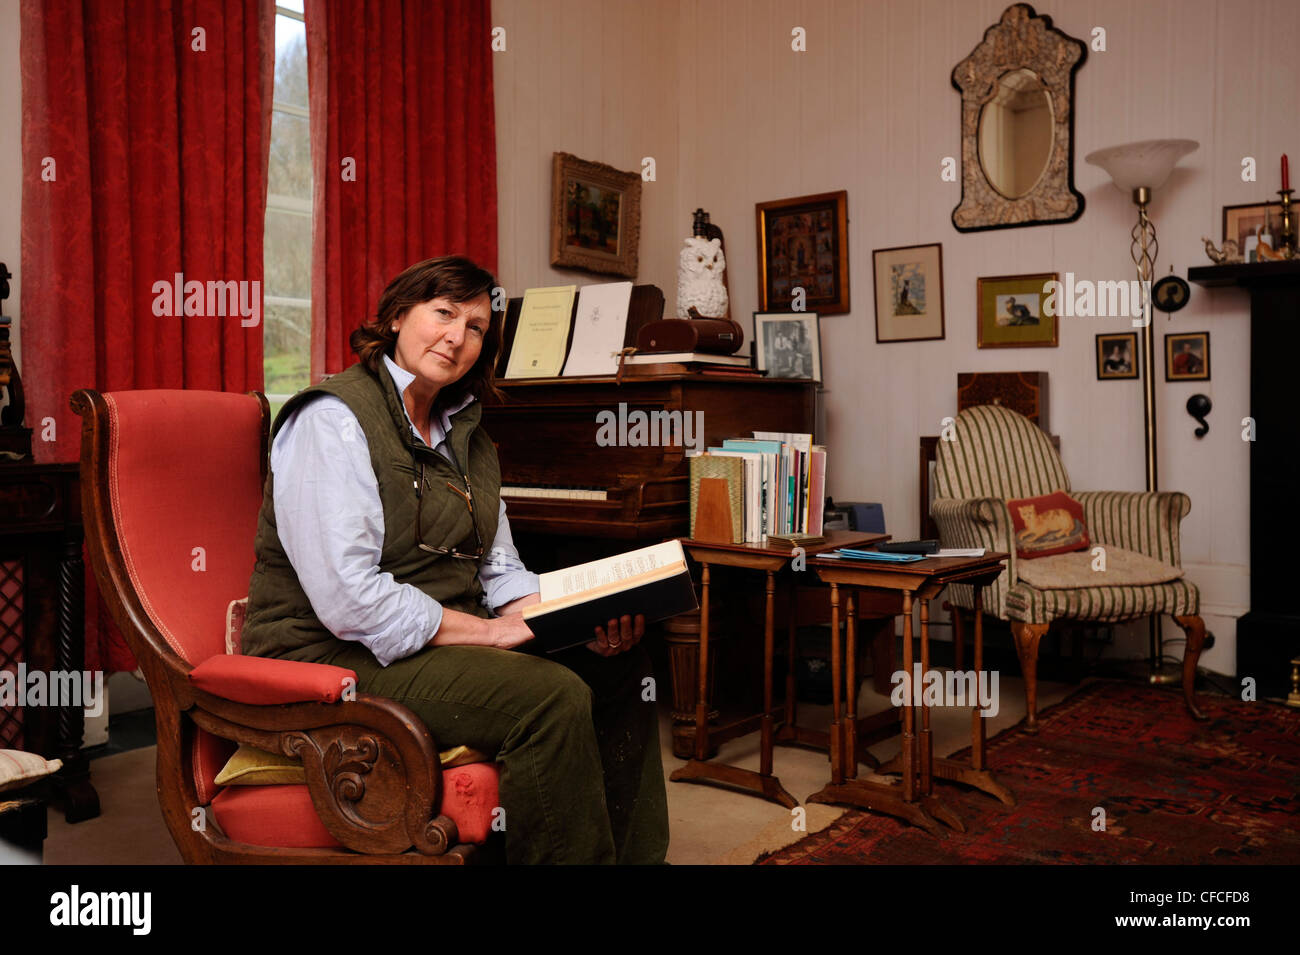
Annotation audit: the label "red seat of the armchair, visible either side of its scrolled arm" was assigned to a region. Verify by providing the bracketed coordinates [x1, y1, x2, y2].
[212, 763, 501, 848]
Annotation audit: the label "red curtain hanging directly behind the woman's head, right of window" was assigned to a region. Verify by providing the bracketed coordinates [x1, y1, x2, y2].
[306, 0, 497, 381]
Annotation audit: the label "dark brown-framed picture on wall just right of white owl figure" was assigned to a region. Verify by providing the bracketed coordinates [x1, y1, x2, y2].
[754, 190, 849, 314]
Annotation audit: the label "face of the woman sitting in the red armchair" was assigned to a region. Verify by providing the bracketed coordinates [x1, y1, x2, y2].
[393, 295, 491, 391]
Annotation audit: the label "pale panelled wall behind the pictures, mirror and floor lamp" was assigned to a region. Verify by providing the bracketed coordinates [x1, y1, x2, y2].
[493, 0, 1300, 673]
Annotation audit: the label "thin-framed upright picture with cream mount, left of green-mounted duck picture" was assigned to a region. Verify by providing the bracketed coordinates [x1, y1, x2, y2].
[871, 242, 944, 342]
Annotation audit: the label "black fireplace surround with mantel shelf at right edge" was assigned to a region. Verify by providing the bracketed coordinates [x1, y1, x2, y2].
[1187, 260, 1300, 696]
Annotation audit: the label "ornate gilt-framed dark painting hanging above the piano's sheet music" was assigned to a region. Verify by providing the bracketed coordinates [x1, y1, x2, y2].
[551, 152, 641, 279]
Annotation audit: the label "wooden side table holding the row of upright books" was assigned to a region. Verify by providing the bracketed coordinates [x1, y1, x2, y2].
[668, 530, 887, 809]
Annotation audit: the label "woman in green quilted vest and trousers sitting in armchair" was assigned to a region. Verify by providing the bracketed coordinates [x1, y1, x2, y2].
[242, 256, 668, 863]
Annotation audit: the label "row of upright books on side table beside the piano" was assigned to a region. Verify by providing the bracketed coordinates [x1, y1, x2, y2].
[690, 431, 826, 543]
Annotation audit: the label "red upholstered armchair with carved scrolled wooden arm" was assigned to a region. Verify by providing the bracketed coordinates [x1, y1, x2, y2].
[72, 390, 498, 864]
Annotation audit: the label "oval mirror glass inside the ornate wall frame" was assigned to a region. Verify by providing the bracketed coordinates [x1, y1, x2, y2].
[979, 69, 1056, 199]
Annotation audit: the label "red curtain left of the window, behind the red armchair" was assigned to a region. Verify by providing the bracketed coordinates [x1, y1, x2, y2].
[21, 0, 274, 669]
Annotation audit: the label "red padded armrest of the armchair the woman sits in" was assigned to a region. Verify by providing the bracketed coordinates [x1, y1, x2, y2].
[190, 654, 356, 706]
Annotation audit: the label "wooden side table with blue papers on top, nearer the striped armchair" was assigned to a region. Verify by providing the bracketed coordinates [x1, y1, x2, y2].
[809, 552, 1015, 835]
